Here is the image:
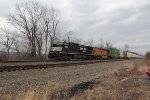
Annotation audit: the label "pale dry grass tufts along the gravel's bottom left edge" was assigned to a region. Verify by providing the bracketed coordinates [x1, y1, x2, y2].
[0, 82, 61, 100]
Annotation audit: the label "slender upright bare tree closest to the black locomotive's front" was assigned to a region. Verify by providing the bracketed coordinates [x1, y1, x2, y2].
[41, 7, 59, 58]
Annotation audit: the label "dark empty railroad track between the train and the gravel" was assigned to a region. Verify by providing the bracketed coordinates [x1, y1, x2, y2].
[0, 59, 124, 72]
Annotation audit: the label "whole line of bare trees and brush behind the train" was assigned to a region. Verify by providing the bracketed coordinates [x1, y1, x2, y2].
[0, 1, 112, 60]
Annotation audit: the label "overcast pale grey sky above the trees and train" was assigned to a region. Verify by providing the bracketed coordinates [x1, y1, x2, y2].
[0, 0, 150, 53]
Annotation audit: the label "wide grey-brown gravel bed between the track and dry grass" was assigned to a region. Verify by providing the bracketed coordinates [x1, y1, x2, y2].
[0, 60, 138, 100]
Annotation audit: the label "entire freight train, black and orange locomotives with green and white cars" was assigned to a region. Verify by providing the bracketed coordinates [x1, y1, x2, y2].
[48, 42, 140, 60]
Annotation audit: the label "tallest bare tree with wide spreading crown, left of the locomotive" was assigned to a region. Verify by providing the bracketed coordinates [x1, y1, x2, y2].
[9, 1, 43, 58]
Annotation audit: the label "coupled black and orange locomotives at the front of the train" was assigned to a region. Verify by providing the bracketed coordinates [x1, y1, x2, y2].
[48, 42, 108, 60]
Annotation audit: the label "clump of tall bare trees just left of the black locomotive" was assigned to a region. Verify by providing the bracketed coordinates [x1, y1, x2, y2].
[3, 1, 59, 59]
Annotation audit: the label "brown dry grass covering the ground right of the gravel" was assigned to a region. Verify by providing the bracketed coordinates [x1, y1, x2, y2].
[72, 60, 150, 100]
